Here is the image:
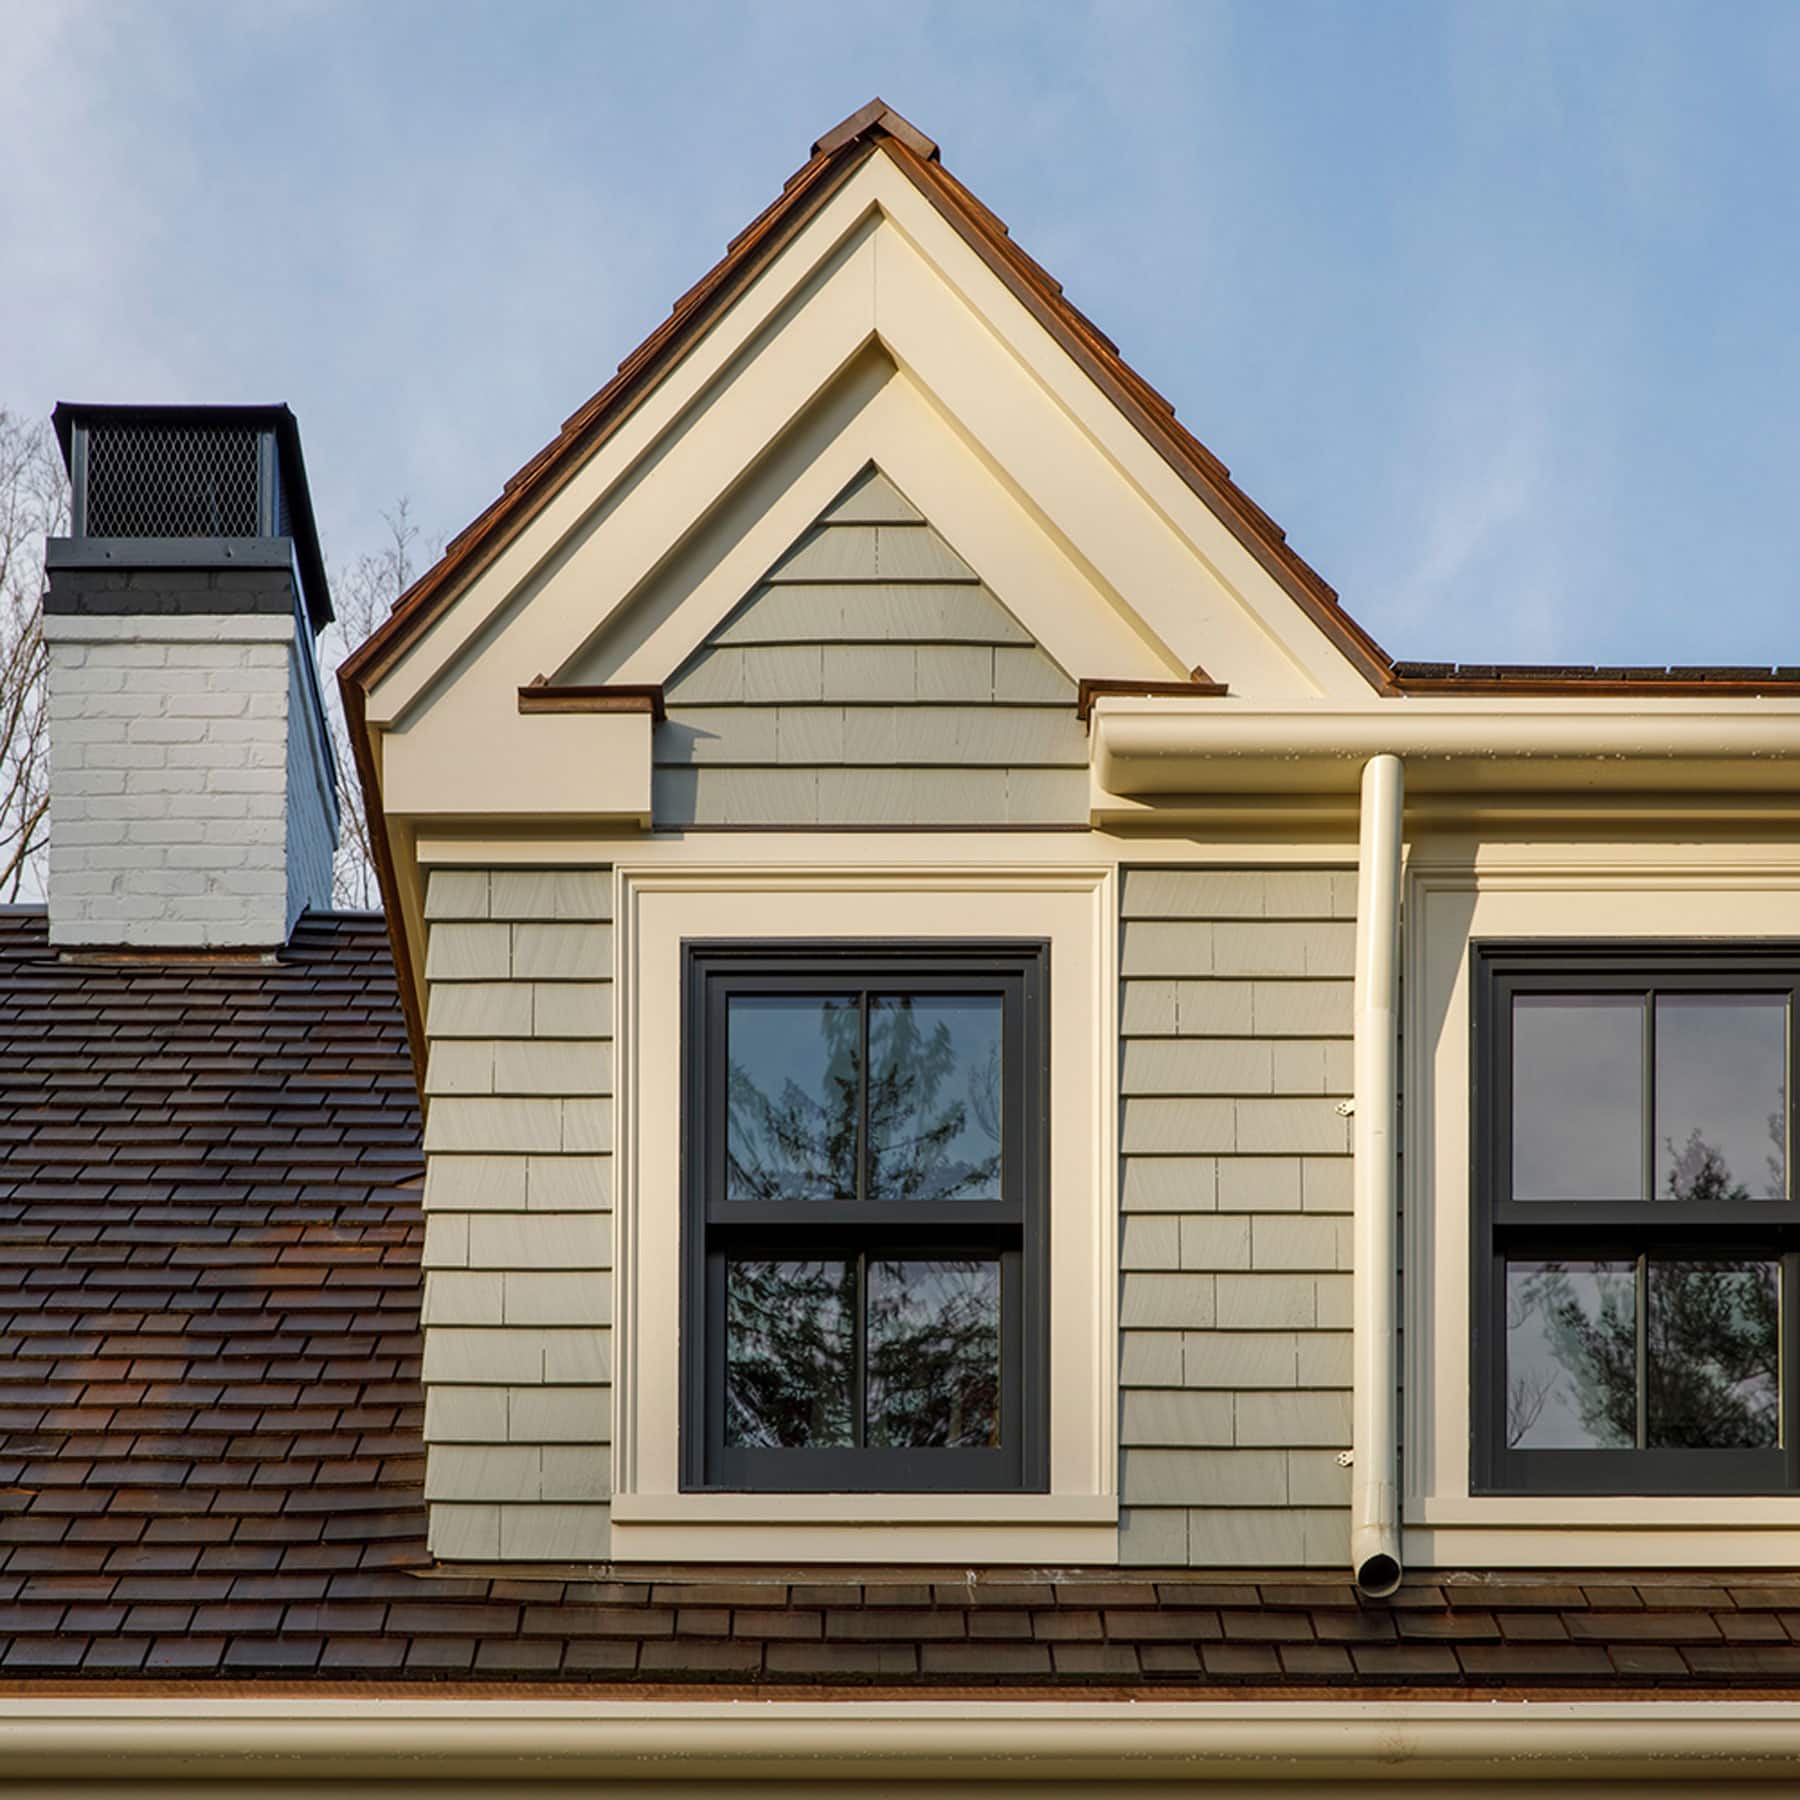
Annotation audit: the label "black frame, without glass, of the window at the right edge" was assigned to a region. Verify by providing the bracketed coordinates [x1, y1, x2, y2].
[1471, 940, 1800, 1496]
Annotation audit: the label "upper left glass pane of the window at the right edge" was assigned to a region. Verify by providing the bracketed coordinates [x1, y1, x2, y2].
[1512, 994, 1643, 1201]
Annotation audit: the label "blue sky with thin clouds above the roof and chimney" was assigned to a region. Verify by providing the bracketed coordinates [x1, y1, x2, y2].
[0, 0, 1800, 662]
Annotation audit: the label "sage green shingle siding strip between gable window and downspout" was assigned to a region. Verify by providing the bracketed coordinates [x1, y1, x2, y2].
[1120, 868, 1355, 1566]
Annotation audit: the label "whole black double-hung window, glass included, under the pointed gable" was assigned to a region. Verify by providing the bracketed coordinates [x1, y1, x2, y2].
[680, 941, 1049, 1492]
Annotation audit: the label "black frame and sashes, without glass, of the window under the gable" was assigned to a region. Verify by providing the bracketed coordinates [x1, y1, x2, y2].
[679, 938, 1049, 1494]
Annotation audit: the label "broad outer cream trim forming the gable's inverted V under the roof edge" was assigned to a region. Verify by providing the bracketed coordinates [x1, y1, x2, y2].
[367, 157, 1379, 725]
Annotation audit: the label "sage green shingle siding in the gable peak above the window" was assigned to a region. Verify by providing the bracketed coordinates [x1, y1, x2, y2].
[653, 470, 1087, 826]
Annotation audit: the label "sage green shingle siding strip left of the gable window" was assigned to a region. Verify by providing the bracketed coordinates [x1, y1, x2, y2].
[425, 869, 612, 1562]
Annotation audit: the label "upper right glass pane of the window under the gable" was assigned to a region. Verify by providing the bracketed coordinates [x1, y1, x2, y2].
[869, 994, 1001, 1201]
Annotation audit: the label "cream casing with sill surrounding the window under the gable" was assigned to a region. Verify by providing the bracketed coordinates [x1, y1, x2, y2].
[612, 864, 1118, 1564]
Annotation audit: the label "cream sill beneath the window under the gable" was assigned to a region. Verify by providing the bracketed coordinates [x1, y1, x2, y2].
[612, 1494, 1118, 1564]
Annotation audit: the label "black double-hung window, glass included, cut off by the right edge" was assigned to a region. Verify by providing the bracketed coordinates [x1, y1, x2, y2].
[1472, 943, 1800, 1494]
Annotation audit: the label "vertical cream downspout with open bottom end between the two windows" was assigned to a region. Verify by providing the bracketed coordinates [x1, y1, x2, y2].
[1350, 754, 1406, 1598]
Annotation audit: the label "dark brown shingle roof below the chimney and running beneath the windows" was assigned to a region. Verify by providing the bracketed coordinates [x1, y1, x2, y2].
[0, 911, 1800, 1697]
